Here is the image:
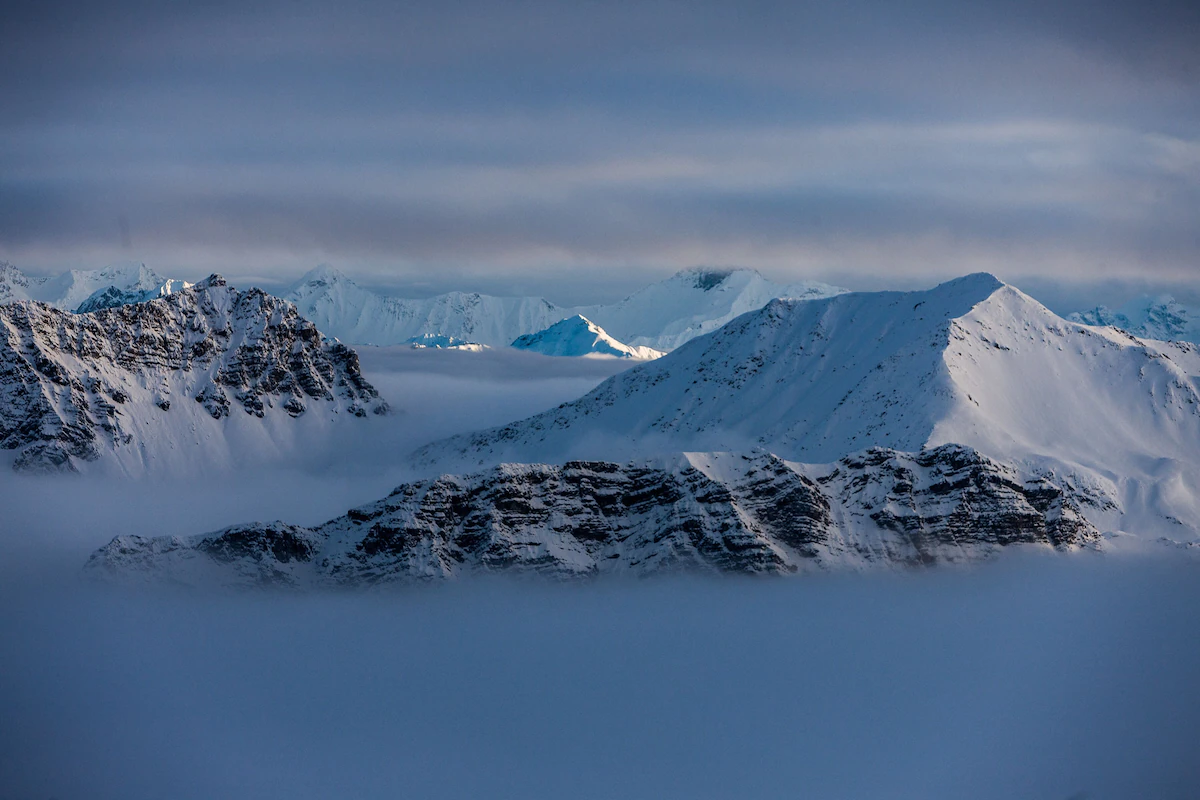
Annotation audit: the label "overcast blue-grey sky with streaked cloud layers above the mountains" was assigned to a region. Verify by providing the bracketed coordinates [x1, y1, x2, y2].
[0, 0, 1200, 302]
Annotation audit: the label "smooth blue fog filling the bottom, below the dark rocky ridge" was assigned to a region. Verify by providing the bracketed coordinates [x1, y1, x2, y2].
[0, 558, 1200, 800]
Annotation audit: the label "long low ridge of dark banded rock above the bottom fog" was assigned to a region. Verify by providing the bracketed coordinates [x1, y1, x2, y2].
[88, 446, 1103, 585]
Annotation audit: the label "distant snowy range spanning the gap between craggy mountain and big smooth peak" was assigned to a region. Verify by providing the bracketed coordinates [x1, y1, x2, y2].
[284, 266, 844, 350]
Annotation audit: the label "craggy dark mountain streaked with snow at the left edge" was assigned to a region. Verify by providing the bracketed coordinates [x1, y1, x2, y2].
[0, 276, 388, 474]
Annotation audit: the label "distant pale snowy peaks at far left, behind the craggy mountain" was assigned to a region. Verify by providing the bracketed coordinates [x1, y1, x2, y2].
[0, 261, 191, 312]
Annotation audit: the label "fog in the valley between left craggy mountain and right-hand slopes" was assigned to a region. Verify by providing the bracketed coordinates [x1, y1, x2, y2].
[0, 347, 630, 569]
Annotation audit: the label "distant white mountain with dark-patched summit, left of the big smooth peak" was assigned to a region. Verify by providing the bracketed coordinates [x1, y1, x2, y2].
[578, 267, 846, 351]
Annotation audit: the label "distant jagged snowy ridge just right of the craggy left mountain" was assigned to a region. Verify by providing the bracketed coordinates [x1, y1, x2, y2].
[284, 266, 569, 347]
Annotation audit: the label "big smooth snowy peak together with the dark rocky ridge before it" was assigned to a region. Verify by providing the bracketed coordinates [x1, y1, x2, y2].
[89, 275, 1200, 585]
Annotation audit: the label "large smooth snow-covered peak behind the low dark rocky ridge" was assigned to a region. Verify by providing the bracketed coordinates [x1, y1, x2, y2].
[418, 275, 1200, 539]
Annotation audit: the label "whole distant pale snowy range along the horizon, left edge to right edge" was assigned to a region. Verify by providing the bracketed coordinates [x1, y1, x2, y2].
[7, 261, 1200, 351]
